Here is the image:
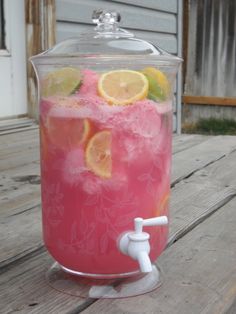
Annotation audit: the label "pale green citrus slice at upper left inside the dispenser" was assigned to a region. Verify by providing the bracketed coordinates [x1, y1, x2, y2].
[41, 67, 82, 97]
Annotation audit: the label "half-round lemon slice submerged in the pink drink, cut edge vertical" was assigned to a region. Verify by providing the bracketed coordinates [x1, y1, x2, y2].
[85, 131, 112, 178]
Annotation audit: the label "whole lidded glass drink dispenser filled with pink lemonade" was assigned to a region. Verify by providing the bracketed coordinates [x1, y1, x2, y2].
[31, 11, 181, 298]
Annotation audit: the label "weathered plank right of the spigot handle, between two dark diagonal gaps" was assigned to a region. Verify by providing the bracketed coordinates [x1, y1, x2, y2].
[169, 146, 236, 243]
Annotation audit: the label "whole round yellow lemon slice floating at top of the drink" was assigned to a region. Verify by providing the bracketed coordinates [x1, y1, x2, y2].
[98, 70, 148, 105]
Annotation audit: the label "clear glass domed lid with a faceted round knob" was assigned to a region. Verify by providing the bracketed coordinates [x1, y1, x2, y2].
[32, 10, 181, 65]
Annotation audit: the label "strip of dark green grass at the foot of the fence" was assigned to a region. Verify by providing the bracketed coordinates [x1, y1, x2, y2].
[183, 118, 236, 135]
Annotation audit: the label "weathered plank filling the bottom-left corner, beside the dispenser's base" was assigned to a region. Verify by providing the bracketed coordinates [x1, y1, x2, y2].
[0, 253, 90, 314]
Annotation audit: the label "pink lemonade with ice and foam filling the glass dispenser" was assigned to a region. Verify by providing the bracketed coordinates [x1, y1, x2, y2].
[40, 70, 172, 278]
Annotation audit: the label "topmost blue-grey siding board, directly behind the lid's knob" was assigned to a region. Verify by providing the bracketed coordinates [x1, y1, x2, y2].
[56, 0, 177, 34]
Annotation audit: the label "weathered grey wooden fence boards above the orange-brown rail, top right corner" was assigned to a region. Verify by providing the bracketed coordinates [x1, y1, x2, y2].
[185, 0, 236, 97]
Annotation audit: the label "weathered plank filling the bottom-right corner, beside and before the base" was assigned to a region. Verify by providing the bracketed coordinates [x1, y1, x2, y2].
[79, 198, 236, 314]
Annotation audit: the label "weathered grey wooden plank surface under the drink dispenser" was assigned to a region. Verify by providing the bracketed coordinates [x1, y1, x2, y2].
[0, 125, 236, 314]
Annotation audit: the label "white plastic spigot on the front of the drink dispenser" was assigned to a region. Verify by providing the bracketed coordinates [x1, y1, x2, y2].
[119, 216, 168, 273]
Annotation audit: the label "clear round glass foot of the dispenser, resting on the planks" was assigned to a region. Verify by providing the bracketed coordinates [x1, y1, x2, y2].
[46, 263, 162, 299]
